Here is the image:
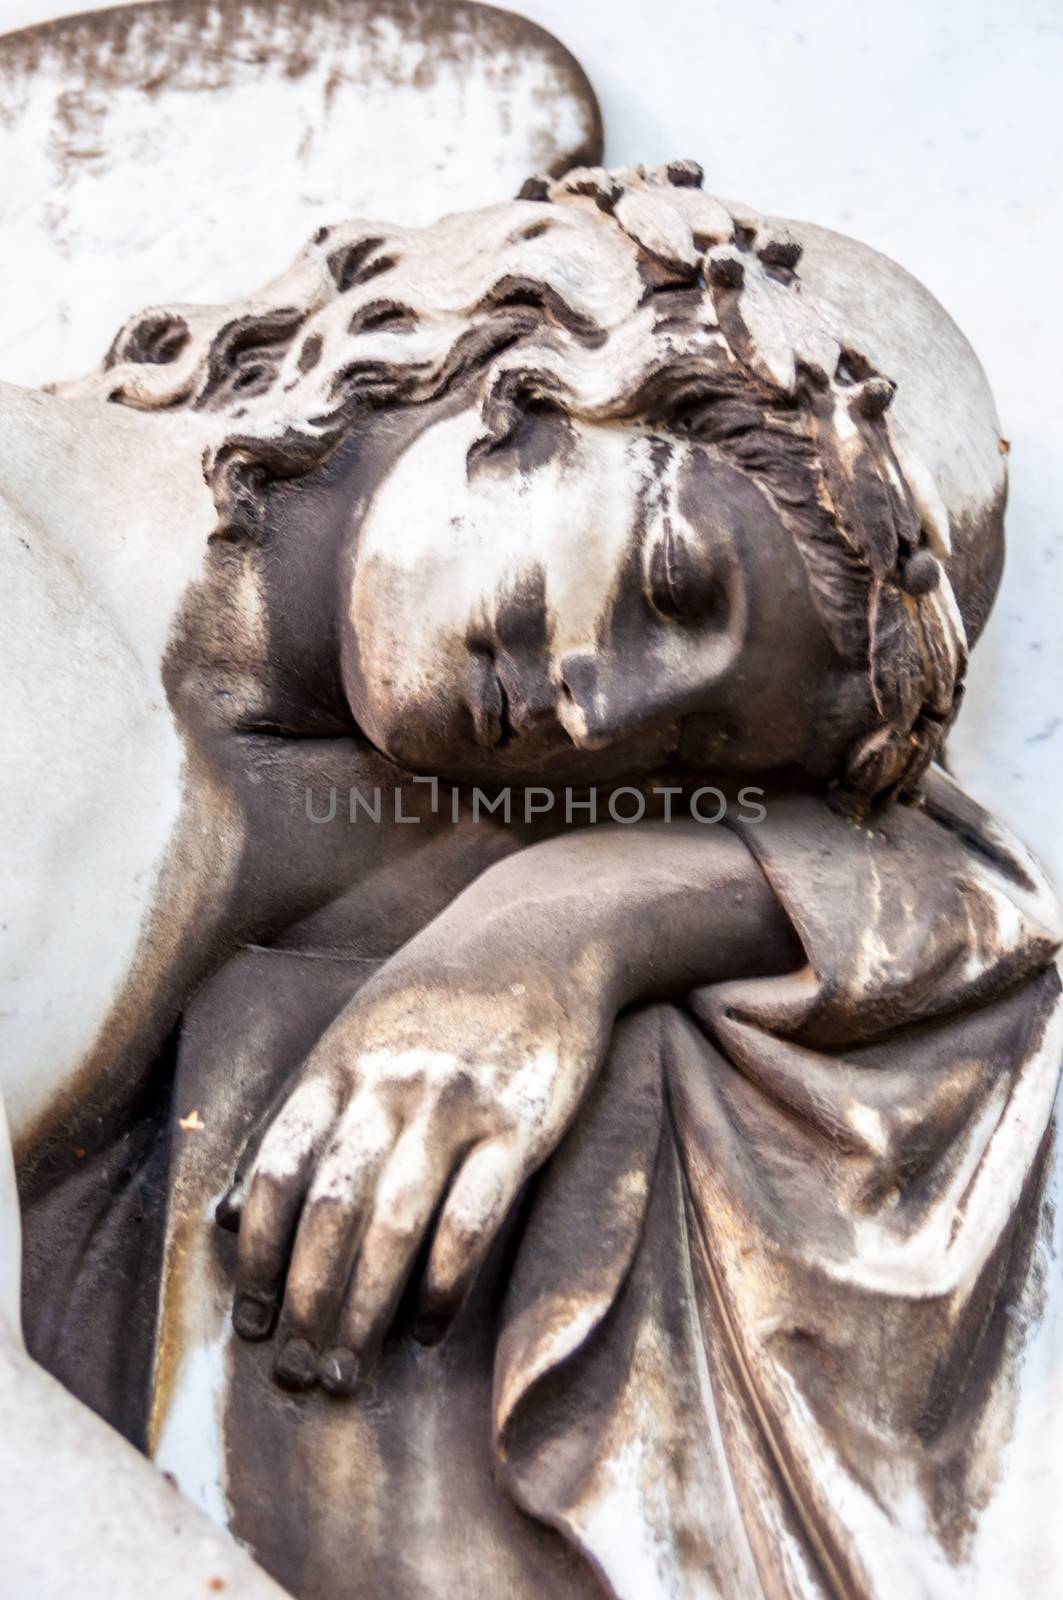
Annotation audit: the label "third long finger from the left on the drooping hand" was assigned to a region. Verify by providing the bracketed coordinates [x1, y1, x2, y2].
[319, 1123, 453, 1394]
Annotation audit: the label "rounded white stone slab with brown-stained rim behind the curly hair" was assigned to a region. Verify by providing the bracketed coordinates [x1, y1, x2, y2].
[0, 0, 602, 384]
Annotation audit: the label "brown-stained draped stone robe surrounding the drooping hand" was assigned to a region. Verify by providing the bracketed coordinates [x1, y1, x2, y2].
[18, 774, 1063, 1600]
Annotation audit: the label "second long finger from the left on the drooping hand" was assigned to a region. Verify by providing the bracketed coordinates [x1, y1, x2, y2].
[274, 1094, 395, 1389]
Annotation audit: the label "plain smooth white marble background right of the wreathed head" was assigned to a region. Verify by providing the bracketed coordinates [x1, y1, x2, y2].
[0, 0, 1063, 883]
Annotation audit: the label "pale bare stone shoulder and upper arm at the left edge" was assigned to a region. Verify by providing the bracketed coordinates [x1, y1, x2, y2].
[0, 386, 243, 1147]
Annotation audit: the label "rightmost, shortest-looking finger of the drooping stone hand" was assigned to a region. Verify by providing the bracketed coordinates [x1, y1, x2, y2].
[413, 1141, 527, 1344]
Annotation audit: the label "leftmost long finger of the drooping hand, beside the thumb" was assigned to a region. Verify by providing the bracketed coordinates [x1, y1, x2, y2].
[232, 1078, 338, 1339]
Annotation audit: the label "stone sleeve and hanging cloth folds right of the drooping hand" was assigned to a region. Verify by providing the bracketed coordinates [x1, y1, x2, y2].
[495, 778, 1063, 1600]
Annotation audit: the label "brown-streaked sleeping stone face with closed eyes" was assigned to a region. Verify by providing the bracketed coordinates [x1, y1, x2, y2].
[344, 393, 836, 781]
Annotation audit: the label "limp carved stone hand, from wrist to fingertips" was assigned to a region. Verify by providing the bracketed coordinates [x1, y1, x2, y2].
[222, 940, 615, 1394]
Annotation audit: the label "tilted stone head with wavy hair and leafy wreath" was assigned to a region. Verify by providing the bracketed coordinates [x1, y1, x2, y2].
[78, 163, 1002, 800]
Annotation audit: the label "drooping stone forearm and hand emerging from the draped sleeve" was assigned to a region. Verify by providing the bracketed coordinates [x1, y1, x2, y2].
[223, 824, 800, 1394]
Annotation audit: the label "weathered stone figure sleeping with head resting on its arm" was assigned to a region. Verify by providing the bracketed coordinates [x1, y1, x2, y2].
[0, 34, 1063, 1600]
